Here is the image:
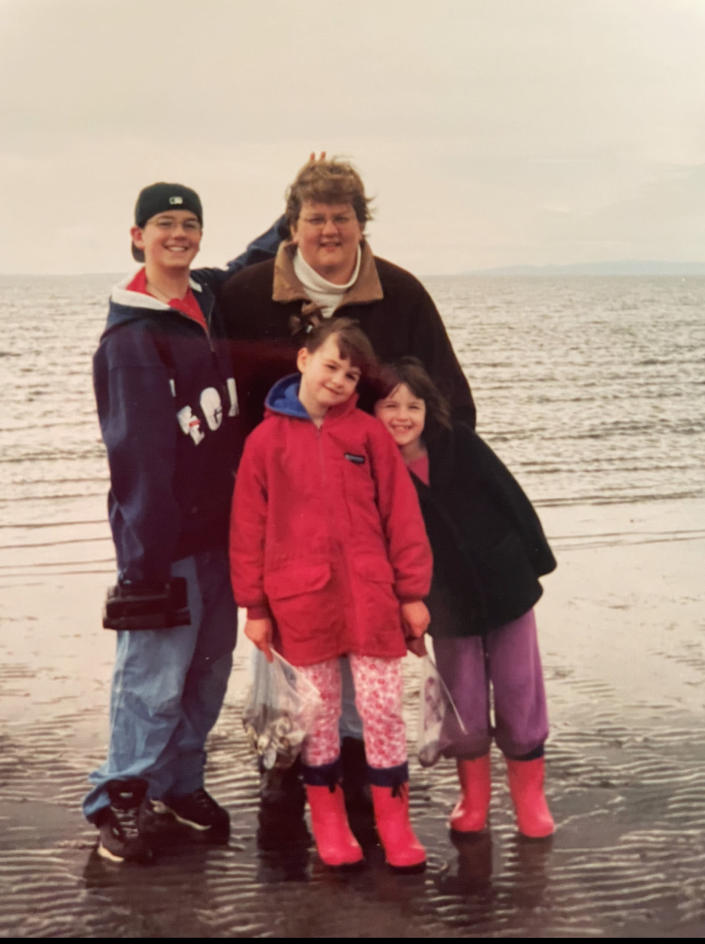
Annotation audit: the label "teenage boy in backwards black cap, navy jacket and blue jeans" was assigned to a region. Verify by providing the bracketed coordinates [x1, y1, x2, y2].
[83, 183, 280, 861]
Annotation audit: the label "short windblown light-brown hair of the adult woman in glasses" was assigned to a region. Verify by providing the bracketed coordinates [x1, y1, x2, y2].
[285, 157, 372, 229]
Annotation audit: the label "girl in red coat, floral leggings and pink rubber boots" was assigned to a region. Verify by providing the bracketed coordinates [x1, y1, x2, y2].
[230, 318, 432, 868]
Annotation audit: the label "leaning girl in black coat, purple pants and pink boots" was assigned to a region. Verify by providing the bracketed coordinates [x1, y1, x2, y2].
[375, 357, 556, 838]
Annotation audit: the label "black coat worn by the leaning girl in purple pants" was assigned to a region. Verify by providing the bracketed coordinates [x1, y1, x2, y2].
[412, 423, 556, 636]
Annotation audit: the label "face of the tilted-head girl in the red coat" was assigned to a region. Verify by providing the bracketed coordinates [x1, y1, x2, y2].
[296, 334, 361, 420]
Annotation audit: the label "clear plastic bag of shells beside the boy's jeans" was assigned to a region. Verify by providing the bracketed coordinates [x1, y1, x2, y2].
[242, 649, 321, 770]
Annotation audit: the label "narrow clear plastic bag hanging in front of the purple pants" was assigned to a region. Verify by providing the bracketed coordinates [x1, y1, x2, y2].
[416, 653, 467, 767]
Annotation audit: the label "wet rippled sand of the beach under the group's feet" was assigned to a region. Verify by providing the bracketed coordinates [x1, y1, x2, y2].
[0, 500, 705, 938]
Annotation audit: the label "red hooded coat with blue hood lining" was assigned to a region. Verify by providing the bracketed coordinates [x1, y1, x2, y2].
[230, 376, 433, 665]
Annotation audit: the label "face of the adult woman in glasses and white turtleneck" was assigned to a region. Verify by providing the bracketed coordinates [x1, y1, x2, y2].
[292, 200, 362, 285]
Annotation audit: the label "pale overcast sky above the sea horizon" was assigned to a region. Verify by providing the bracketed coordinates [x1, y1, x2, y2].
[0, 0, 705, 275]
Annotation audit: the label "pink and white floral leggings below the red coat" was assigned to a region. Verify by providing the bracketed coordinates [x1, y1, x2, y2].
[297, 654, 406, 768]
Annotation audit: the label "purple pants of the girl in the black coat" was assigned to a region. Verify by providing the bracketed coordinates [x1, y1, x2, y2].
[433, 609, 548, 759]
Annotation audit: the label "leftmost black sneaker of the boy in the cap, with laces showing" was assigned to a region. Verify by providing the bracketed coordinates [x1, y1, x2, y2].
[96, 779, 154, 862]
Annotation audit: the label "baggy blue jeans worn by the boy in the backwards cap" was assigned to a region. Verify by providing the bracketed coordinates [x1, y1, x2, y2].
[83, 550, 237, 821]
